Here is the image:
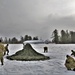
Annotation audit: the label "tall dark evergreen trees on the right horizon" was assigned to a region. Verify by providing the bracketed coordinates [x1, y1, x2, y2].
[52, 29, 75, 44]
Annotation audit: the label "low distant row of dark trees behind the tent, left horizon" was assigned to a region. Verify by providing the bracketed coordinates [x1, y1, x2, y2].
[0, 35, 39, 44]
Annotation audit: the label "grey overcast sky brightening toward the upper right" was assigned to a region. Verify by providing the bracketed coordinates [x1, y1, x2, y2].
[0, 0, 75, 39]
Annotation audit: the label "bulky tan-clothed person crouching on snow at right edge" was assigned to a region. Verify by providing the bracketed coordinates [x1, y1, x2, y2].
[65, 55, 75, 71]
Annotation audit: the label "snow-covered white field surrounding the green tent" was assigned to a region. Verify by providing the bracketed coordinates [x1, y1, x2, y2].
[0, 44, 75, 75]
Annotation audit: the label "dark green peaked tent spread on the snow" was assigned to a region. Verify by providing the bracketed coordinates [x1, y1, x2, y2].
[7, 43, 50, 61]
